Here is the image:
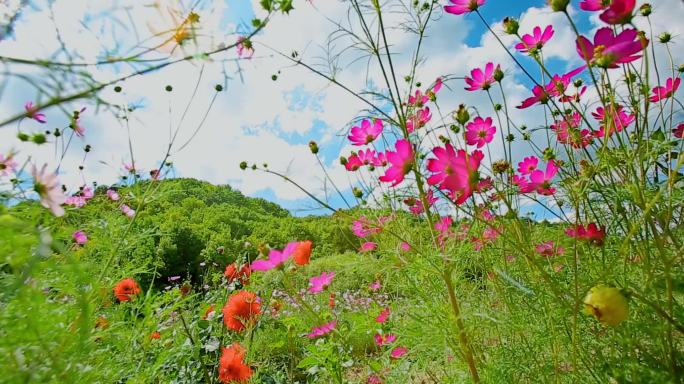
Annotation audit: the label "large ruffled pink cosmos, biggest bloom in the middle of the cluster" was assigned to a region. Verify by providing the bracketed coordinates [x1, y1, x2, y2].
[427, 143, 484, 205]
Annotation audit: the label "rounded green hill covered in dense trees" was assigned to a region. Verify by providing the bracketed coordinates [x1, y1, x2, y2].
[6, 179, 359, 281]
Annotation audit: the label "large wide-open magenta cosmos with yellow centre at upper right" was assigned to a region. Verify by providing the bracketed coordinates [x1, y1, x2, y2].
[577, 27, 648, 68]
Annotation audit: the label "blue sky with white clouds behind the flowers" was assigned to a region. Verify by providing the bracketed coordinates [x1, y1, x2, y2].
[0, 0, 684, 214]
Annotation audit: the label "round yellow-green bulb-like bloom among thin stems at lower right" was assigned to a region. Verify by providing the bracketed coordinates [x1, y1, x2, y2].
[584, 285, 629, 326]
